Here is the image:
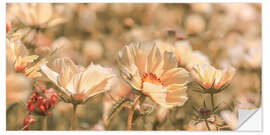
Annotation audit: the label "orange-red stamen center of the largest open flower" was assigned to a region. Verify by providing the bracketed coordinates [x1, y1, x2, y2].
[141, 73, 163, 89]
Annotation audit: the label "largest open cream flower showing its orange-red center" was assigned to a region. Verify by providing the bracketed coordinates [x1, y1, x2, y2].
[117, 42, 189, 108]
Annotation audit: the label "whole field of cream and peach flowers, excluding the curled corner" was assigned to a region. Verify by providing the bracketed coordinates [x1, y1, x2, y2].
[6, 3, 262, 130]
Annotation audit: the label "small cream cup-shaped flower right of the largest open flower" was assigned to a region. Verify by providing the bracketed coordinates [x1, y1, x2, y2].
[191, 64, 235, 93]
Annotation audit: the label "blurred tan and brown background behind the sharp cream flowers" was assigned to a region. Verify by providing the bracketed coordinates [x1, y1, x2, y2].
[6, 3, 262, 130]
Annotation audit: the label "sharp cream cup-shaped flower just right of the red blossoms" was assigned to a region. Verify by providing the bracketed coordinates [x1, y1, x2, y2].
[41, 57, 114, 104]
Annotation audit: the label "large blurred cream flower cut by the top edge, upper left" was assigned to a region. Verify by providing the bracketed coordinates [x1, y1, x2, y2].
[12, 3, 65, 28]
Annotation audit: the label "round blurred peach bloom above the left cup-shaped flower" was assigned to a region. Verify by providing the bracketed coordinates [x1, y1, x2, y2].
[82, 41, 103, 62]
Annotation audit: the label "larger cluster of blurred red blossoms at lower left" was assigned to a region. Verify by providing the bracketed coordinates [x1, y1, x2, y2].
[27, 84, 58, 115]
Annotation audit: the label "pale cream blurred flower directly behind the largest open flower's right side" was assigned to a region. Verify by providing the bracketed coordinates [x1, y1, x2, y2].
[174, 40, 210, 70]
